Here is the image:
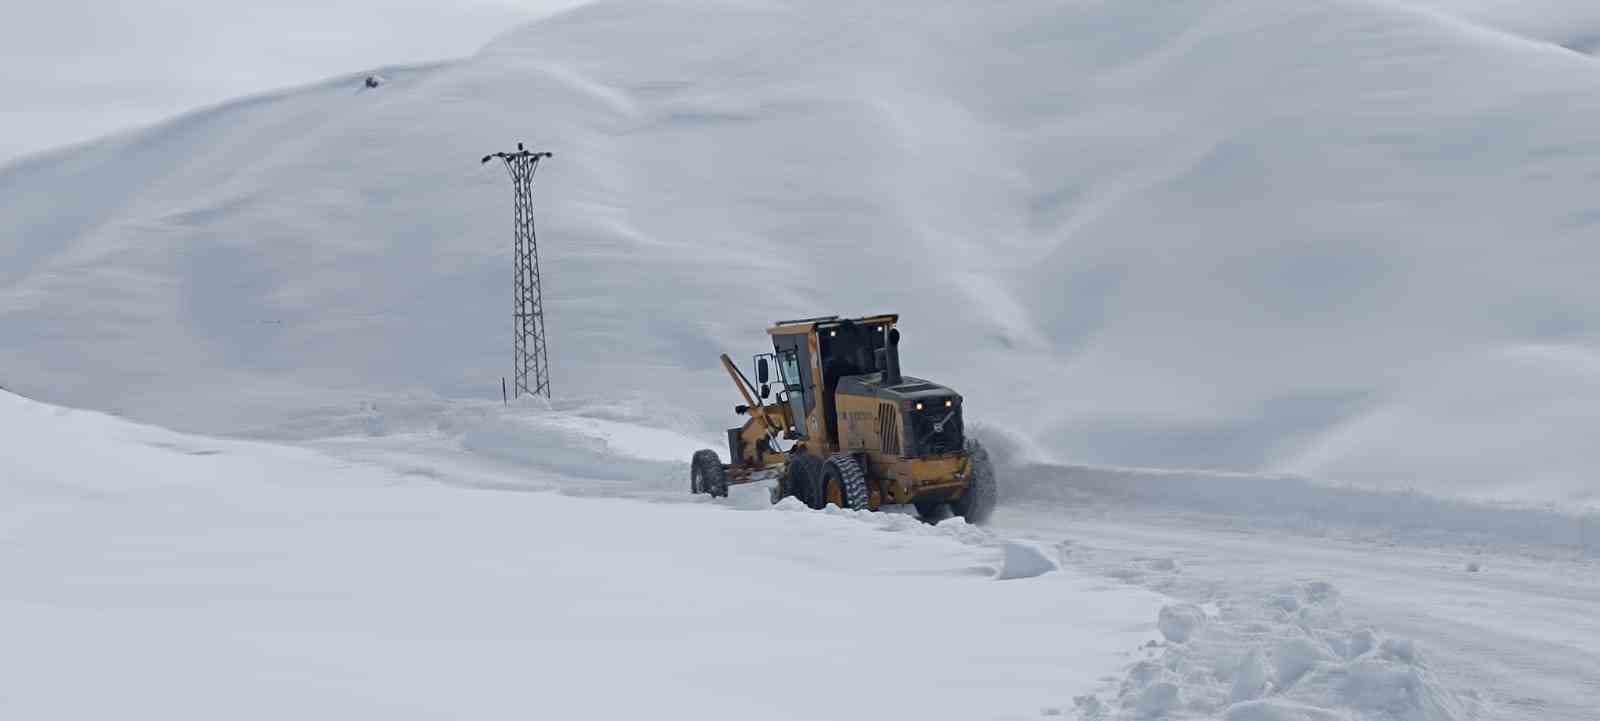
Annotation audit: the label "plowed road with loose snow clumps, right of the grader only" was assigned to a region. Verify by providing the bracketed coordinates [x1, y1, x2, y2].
[995, 489, 1600, 721]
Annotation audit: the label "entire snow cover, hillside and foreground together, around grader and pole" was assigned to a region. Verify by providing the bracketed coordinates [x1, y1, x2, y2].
[0, 0, 1600, 721]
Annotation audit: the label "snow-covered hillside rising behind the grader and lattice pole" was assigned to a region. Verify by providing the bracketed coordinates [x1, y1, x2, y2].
[0, 0, 1600, 502]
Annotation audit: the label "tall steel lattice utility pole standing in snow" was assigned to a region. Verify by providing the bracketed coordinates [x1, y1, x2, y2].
[482, 142, 550, 398]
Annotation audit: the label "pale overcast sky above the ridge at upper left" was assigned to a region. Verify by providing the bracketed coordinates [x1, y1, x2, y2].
[0, 0, 581, 163]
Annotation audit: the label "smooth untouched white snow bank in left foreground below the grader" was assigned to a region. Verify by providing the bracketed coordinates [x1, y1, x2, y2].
[0, 393, 1163, 719]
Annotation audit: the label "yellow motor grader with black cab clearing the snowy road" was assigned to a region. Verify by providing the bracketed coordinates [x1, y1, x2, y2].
[690, 315, 995, 523]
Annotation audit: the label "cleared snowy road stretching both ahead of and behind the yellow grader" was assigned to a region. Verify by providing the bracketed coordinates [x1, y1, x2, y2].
[302, 406, 1600, 721]
